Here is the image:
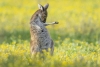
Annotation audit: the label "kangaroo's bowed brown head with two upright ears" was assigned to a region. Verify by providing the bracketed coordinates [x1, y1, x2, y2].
[38, 4, 49, 23]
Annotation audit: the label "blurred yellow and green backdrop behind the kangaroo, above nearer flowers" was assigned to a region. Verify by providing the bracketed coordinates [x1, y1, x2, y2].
[0, 0, 100, 43]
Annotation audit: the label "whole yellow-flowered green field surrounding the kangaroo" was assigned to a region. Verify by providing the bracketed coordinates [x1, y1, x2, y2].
[0, 0, 100, 67]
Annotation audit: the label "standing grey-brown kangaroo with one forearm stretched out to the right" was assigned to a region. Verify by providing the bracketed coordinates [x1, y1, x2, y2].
[30, 4, 58, 55]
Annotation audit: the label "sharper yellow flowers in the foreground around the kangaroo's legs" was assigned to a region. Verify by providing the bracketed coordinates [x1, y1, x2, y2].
[0, 39, 100, 67]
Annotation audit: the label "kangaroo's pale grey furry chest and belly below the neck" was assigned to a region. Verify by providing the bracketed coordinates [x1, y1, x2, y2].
[32, 21, 51, 48]
